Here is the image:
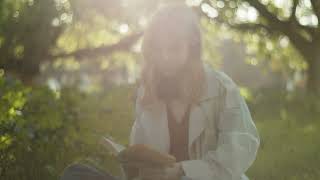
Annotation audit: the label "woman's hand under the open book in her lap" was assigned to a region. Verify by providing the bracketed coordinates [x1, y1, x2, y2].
[139, 163, 184, 180]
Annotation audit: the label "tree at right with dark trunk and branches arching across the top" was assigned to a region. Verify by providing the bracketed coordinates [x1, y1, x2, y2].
[200, 0, 320, 94]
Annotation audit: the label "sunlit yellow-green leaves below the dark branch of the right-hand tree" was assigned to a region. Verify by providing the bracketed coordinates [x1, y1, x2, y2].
[241, 32, 308, 80]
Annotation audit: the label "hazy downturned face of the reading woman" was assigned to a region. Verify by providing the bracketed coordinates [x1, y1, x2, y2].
[156, 42, 188, 77]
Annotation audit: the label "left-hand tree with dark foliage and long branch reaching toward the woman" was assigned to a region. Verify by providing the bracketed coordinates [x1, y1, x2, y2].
[0, 0, 141, 84]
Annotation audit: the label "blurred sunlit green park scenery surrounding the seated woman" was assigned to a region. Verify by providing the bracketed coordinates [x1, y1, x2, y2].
[0, 0, 320, 180]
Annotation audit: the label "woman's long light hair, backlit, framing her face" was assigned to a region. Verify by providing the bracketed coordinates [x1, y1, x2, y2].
[139, 4, 205, 109]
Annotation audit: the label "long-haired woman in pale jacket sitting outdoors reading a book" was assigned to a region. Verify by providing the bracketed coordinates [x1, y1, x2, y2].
[60, 4, 260, 180]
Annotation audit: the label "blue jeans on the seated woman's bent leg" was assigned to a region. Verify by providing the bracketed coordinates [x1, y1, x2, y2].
[60, 163, 191, 180]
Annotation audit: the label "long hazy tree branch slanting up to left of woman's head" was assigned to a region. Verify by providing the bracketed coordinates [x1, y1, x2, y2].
[46, 32, 143, 60]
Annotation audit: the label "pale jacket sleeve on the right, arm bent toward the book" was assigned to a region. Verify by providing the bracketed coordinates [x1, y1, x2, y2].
[182, 86, 260, 180]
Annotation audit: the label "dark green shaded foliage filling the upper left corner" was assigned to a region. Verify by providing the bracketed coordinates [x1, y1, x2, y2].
[0, 0, 68, 79]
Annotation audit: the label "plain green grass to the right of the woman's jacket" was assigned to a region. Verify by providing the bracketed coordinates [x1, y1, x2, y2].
[247, 102, 320, 180]
